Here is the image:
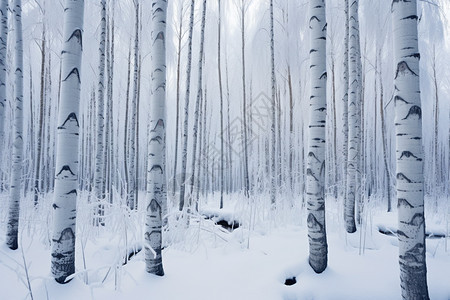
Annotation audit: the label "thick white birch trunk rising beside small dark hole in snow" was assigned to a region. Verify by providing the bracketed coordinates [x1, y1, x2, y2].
[306, 0, 328, 273]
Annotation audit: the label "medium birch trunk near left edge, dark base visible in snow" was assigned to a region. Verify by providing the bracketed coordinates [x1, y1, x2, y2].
[6, 0, 23, 250]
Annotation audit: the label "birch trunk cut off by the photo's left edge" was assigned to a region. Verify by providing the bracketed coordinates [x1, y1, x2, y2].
[0, 0, 9, 191]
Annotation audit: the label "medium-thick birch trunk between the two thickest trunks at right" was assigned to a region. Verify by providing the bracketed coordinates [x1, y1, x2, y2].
[344, 0, 361, 233]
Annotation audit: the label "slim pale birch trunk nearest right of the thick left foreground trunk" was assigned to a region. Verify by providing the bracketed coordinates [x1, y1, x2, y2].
[94, 0, 106, 213]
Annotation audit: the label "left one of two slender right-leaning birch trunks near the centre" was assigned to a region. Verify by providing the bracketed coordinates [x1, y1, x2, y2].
[179, 0, 195, 211]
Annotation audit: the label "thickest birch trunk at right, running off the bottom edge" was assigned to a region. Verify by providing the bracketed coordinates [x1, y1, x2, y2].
[392, 0, 429, 299]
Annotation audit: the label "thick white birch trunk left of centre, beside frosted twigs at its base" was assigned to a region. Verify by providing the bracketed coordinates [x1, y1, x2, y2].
[145, 0, 167, 276]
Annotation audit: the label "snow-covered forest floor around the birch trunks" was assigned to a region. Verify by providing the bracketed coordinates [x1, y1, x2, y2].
[0, 191, 450, 300]
